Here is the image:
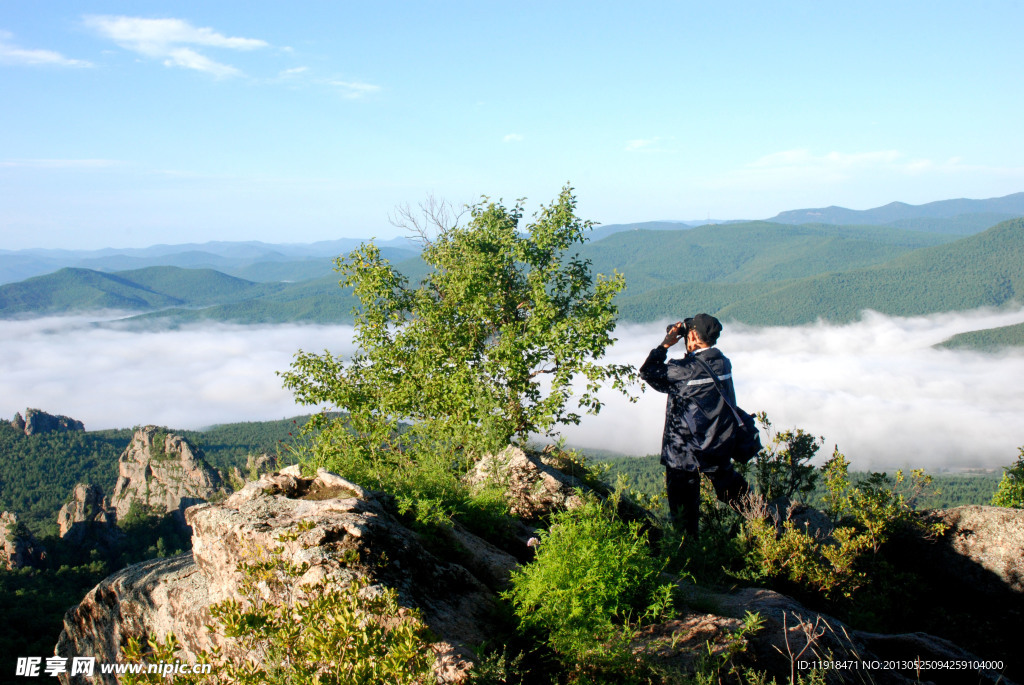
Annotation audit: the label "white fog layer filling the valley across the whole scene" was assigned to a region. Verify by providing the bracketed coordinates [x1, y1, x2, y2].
[0, 310, 1024, 470]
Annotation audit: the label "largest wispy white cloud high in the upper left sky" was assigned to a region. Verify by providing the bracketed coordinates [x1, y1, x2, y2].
[85, 15, 267, 78]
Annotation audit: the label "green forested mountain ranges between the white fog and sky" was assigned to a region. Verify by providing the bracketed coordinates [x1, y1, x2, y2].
[0, 194, 1024, 345]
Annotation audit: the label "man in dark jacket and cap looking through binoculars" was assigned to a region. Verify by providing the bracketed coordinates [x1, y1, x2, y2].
[640, 314, 750, 534]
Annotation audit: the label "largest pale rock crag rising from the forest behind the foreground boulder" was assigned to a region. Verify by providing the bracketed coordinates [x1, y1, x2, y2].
[111, 426, 223, 524]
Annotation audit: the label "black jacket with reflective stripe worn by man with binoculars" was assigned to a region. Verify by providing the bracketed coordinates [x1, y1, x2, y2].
[640, 345, 736, 471]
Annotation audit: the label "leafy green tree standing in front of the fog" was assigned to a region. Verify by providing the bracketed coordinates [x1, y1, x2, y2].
[283, 186, 633, 471]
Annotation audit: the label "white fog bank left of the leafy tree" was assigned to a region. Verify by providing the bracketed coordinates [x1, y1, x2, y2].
[0, 316, 352, 430]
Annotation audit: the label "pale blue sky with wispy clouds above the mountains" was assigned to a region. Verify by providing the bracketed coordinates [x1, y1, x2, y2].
[0, 0, 1024, 249]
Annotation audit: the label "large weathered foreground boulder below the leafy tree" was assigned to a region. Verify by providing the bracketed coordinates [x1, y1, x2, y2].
[56, 469, 516, 682]
